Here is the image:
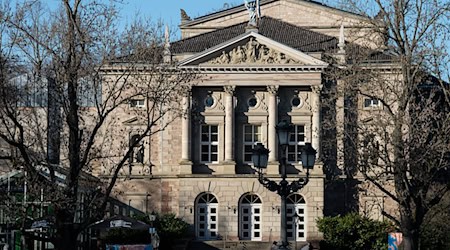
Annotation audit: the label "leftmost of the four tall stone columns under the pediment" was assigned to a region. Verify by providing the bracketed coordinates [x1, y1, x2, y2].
[181, 92, 192, 172]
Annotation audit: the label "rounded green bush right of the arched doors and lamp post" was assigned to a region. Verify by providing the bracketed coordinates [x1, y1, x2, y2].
[317, 213, 394, 250]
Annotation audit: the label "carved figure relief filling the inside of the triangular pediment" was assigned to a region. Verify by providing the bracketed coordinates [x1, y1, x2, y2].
[208, 37, 301, 64]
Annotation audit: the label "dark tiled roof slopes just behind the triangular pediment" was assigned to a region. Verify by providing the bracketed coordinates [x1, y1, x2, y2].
[171, 16, 339, 54]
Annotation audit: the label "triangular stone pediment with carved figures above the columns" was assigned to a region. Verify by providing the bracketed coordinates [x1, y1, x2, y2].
[179, 32, 328, 67]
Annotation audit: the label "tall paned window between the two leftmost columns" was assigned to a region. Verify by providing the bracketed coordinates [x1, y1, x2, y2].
[200, 125, 219, 163]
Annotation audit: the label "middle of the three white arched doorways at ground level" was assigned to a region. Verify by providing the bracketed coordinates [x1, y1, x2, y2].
[239, 193, 262, 240]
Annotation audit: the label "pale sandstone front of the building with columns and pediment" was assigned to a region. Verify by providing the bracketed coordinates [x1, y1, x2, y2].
[104, 0, 398, 241]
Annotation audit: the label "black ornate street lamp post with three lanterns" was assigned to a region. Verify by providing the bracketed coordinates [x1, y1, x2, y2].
[252, 120, 317, 249]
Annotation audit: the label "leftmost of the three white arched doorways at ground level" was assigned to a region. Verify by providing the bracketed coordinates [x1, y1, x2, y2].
[195, 193, 219, 240]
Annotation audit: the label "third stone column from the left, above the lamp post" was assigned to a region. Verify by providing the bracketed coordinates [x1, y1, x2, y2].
[267, 85, 278, 162]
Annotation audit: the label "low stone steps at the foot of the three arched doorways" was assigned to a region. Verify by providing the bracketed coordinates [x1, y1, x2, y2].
[184, 240, 307, 250]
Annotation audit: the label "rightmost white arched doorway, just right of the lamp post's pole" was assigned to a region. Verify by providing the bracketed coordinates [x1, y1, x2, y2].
[286, 194, 307, 241]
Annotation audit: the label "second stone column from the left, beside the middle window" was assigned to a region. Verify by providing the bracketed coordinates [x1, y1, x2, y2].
[224, 86, 235, 164]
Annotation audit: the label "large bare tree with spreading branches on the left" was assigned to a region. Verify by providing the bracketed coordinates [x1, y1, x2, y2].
[0, 0, 196, 249]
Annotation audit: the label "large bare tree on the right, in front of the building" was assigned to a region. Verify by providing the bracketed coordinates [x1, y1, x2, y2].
[328, 0, 450, 249]
